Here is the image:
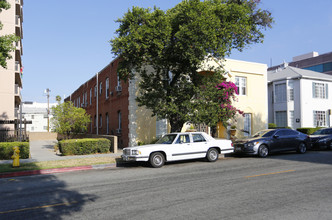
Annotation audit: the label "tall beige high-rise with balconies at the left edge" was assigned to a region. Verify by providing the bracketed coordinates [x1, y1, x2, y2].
[0, 0, 23, 139]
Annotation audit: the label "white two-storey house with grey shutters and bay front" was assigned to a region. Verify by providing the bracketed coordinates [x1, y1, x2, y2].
[268, 66, 332, 129]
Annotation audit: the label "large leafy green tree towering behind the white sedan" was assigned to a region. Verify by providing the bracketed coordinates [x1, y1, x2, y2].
[111, 0, 273, 131]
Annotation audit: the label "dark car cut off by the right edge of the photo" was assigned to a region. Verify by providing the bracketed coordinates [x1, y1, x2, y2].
[309, 128, 332, 150]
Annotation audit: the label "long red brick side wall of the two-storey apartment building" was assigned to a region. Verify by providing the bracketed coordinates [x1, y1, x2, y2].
[64, 58, 166, 148]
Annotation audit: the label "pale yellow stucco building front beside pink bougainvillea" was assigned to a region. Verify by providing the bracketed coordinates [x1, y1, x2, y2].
[200, 58, 268, 138]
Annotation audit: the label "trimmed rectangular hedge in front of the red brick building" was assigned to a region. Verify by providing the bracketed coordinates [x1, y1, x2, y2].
[58, 138, 111, 156]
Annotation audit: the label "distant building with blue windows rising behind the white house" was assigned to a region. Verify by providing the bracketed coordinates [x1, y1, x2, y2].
[268, 52, 332, 75]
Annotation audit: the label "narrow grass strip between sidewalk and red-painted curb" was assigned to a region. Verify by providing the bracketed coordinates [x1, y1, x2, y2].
[0, 157, 116, 173]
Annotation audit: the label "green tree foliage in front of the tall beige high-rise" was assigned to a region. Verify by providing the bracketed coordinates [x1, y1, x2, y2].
[0, 0, 19, 68]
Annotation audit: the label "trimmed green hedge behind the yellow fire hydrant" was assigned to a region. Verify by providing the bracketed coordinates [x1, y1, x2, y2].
[0, 142, 30, 160]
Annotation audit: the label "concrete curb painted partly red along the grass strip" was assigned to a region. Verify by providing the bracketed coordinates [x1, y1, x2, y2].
[0, 163, 116, 179]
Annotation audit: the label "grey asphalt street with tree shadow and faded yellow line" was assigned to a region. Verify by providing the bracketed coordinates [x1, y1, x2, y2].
[0, 151, 332, 220]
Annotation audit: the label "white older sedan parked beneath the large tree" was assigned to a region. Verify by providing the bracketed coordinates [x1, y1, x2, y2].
[122, 132, 234, 168]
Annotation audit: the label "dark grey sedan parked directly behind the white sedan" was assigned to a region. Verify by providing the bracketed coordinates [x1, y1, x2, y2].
[233, 128, 309, 157]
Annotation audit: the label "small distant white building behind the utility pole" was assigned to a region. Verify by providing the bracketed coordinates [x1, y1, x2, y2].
[22, 102, 57, 132]
